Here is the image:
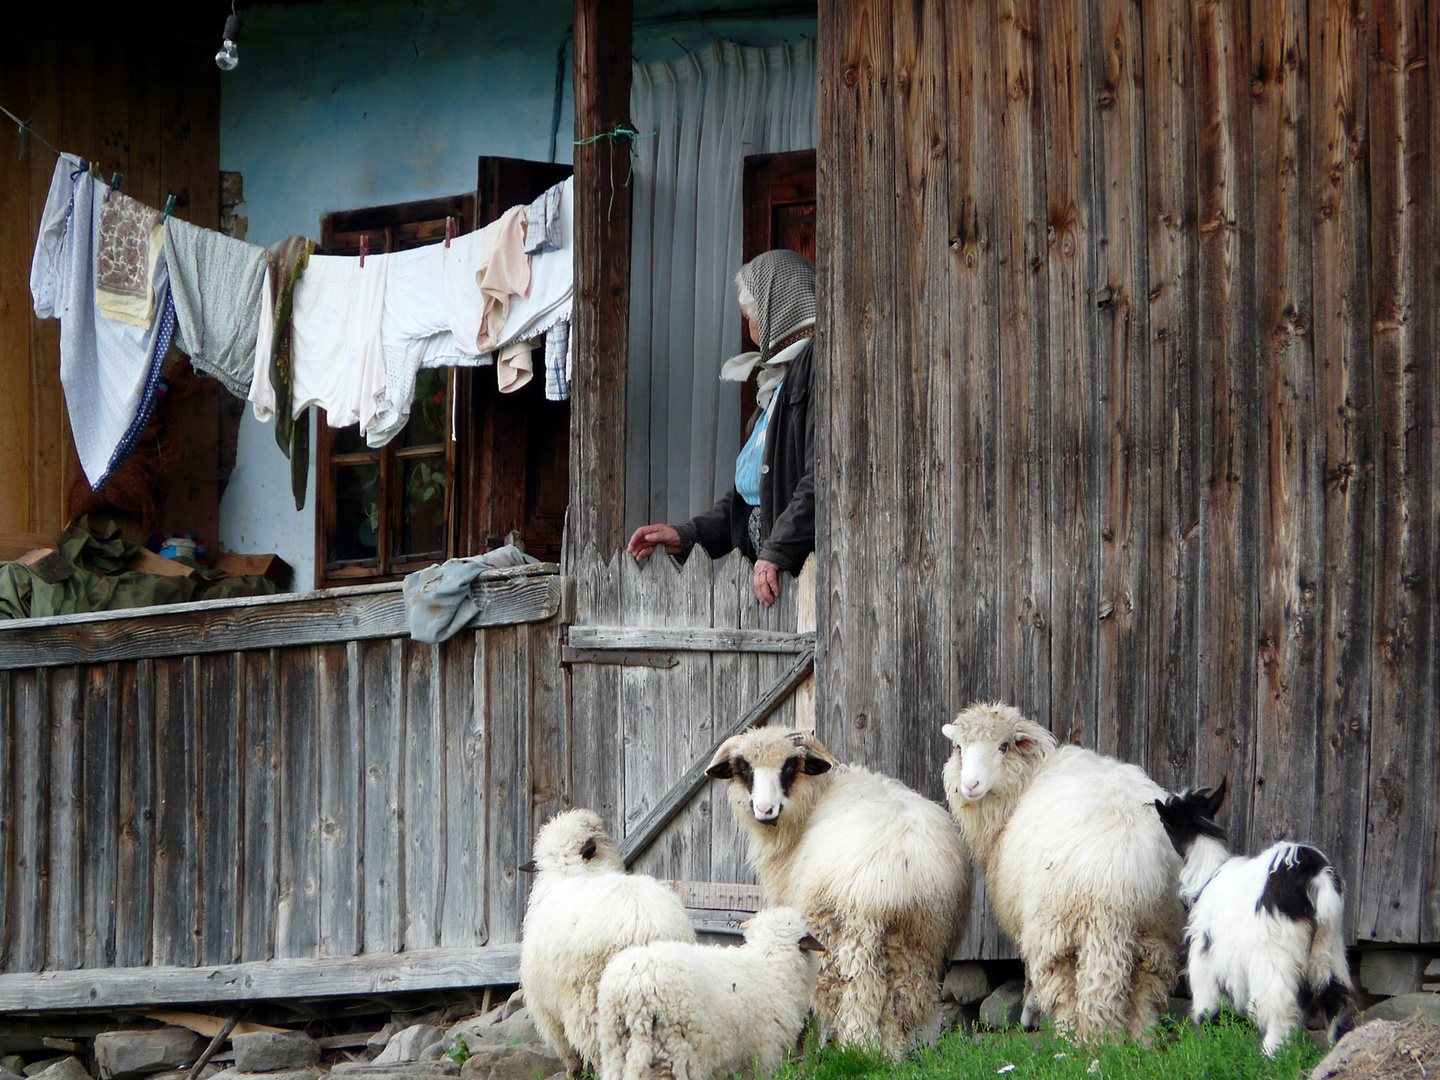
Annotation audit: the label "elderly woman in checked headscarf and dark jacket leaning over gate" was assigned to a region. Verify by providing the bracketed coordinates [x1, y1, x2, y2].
[629, 251, 815, 606]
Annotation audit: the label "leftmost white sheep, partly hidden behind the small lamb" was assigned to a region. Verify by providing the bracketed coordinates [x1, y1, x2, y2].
[520, 809, 696, 1076]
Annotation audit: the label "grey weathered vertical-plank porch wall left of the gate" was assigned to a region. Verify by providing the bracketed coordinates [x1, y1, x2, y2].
[0, 576, 569, 1001]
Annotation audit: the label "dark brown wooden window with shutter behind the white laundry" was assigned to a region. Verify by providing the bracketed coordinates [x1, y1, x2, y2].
[315, 157, 570, 588]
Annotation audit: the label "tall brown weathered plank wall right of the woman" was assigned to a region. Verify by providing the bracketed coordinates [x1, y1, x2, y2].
[818, 0, 1440, 942]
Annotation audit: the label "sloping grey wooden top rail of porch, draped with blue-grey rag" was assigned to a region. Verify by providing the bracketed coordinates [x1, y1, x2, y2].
[0, 563, 560, 671]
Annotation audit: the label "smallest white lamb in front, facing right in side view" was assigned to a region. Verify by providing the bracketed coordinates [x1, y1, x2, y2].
[599, 907, 824, 1080]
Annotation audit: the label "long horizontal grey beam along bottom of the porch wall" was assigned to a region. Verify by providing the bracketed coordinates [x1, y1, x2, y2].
[0, 945, 520, 1012]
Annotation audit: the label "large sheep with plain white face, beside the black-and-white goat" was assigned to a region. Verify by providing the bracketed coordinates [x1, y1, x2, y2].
[942, 703, 1184, 1038]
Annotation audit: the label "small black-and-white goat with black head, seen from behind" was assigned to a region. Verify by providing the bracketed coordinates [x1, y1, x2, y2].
[1155, 780, 1352, 1056]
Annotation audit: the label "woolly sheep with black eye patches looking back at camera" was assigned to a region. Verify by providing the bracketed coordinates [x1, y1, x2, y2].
[707, 727, 971, 1057]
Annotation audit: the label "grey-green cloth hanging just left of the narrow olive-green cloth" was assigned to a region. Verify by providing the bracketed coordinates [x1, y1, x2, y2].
[164, 217, 268, 399]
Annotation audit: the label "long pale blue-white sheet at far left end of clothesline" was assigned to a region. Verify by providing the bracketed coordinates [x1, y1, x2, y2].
[30, 154, 174, 490]
